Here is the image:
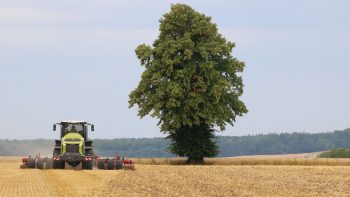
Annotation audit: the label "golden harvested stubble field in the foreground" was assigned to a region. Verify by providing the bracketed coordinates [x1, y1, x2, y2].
[0, 157, 350, 196]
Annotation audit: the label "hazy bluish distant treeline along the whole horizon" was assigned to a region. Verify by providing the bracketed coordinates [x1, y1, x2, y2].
[0, 129, 350, 157]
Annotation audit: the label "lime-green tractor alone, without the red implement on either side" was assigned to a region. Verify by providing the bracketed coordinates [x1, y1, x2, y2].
[52, 121, 94, 170]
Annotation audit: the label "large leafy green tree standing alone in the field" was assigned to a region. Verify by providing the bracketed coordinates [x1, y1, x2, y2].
[129, 4, 247, 162]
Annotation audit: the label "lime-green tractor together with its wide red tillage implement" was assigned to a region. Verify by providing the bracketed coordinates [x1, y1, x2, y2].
[20, 121, 134, 170]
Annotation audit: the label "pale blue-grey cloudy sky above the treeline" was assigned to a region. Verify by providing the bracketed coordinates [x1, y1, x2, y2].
[0, 0, 350, 139]
